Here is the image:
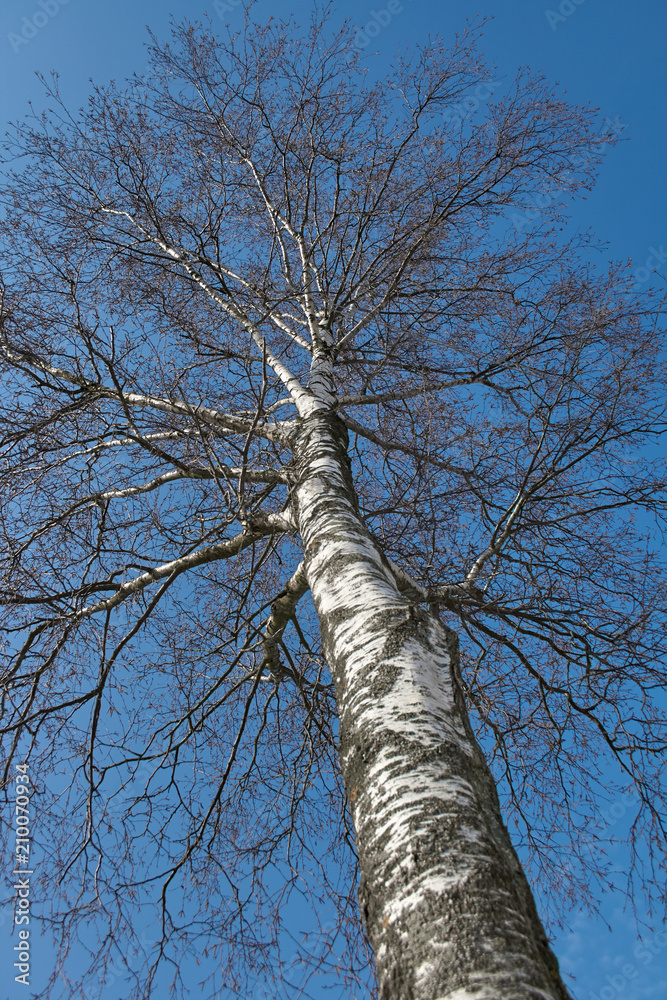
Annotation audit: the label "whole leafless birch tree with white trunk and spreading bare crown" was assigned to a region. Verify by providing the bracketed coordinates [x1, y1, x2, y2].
[1, 9, 666, 1000]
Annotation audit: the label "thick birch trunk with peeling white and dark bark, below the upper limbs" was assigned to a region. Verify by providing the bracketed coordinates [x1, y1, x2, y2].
[297, 410, 568, 1000]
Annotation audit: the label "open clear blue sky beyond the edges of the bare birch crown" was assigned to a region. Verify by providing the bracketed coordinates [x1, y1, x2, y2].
[0, 0, 667, 1000]
